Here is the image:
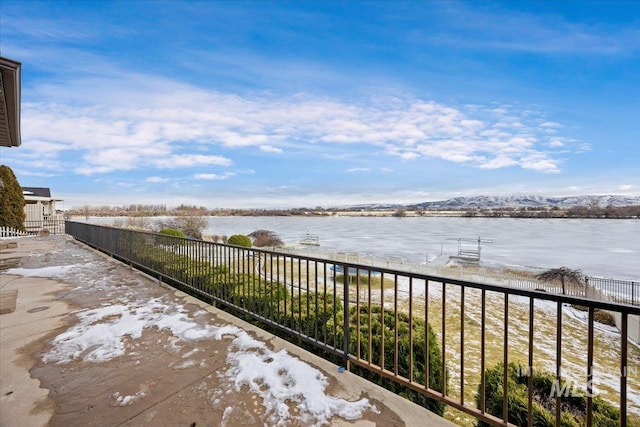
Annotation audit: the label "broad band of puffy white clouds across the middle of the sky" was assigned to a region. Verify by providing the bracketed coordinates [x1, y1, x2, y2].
[13, 74, 585, 175]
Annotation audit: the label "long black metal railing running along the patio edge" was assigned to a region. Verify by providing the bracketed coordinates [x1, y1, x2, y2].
[66, 222, 640, 426]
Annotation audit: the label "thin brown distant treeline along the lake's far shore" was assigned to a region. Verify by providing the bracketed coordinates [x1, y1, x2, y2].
[65, 204, 640, 219]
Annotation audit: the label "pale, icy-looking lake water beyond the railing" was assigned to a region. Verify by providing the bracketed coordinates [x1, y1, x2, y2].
[90, 216, 640, 280]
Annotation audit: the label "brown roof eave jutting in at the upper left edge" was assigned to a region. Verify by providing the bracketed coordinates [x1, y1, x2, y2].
[0, 56, 22, 147]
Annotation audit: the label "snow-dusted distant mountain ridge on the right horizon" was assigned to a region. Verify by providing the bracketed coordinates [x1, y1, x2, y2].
[411, 195, 640, 209]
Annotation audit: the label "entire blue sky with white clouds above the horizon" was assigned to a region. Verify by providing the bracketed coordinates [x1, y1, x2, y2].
[0, 0, 640, 208]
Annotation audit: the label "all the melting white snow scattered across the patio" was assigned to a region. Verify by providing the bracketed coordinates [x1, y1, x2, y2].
[3, 244, 378, 425]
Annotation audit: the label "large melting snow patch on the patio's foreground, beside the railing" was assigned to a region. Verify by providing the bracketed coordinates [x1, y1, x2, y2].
[42, 292, 377, 426]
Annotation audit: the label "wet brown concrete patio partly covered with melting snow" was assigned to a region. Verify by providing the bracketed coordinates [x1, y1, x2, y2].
[0, 236, 453, 427]
